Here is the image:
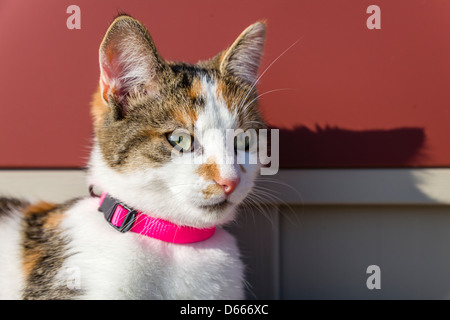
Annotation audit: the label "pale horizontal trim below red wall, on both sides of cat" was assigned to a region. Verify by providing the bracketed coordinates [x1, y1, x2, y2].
[0, 169, 450, 205]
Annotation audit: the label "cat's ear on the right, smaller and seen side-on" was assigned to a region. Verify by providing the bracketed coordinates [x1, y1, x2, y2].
[219, 21, 266, 84]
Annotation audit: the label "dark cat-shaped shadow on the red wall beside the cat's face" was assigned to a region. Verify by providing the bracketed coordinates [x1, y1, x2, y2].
[280, 126, 425, 168]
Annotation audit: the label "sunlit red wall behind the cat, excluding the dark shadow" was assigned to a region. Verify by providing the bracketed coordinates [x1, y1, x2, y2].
[0, 0, 450, 168]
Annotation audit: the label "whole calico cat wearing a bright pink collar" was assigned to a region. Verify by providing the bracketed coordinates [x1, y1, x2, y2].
[0, 15, 266, 299]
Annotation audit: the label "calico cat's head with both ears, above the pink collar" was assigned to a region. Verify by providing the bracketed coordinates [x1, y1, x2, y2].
[90, 15, 266, 227]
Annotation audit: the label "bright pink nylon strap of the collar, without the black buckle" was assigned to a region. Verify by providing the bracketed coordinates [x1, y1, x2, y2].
[99, 192, 216, 243]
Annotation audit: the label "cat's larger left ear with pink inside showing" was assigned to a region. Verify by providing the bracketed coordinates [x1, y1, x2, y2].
[99, 15, 165, 104]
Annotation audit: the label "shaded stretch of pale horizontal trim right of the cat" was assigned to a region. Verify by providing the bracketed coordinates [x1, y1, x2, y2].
[262, 169, 450, 205]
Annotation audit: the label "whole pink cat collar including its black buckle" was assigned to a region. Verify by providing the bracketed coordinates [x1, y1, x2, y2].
[98, 192, 216, 243]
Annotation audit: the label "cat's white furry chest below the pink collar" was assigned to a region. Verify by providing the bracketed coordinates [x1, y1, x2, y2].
[61, 200, 243, 299]
